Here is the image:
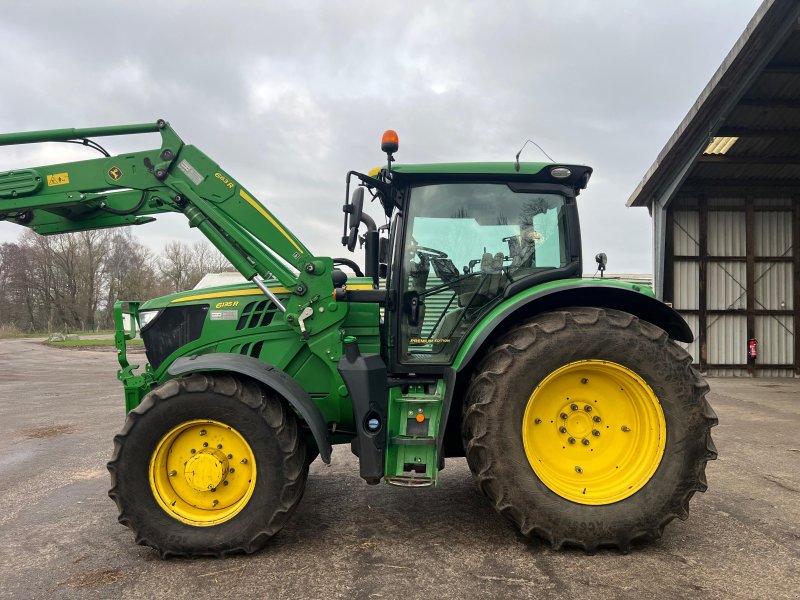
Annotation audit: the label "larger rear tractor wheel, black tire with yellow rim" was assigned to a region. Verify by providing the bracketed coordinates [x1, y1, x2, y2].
[462, 308, 717, 553]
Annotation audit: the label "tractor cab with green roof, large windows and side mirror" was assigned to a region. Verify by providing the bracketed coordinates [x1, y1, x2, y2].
[343, 135, 592, 370]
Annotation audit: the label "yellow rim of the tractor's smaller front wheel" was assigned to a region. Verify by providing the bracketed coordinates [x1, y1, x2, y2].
[150, 420, 256, 527]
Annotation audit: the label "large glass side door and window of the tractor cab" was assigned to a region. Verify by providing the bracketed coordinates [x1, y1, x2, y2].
[401, 183, 569, 363]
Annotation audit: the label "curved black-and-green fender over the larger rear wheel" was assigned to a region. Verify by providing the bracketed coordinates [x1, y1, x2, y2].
[453, 279, 694, 371]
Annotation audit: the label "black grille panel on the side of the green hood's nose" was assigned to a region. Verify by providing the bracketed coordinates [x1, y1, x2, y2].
[141, 304, 208, 369]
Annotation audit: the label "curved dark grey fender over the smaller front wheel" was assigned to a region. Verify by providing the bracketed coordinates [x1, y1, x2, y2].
[167, 352, 333, 464]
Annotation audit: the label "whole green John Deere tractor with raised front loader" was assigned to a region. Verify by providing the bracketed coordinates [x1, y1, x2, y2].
[0, 121, 717, 556]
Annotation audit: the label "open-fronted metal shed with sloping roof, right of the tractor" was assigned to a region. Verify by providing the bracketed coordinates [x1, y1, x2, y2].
[628, 0, 800, 376]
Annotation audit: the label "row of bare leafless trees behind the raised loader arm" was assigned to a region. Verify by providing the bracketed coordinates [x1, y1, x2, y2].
[0, 229, 232, 331]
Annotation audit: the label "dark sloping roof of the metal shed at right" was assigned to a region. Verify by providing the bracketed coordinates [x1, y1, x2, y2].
[628, 0, 800, 206]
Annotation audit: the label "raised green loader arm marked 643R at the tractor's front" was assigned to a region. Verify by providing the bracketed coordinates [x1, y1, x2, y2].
[0, 120, 318, 296]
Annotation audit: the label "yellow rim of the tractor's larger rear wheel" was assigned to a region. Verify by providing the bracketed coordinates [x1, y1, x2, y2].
[522, 360, 667, 505]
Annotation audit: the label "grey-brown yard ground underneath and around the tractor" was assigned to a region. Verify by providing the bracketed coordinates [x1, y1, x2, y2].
[0, 340, 800, 600]
